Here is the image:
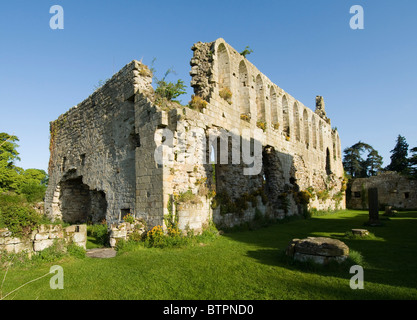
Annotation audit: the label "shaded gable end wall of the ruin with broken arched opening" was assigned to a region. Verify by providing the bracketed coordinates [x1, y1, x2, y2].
[45, 61, 151, 223]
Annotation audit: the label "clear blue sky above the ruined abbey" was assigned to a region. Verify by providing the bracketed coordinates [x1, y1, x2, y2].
[0, 0, 417, 170]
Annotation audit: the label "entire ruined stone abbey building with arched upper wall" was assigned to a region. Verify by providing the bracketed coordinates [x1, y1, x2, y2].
[45, 39, 345, 231]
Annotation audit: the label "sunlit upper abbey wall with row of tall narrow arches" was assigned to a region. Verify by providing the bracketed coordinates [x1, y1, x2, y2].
[190, 39, 343, 209]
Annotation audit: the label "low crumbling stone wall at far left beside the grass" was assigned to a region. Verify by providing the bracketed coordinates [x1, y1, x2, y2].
[0, 225, 87, 255]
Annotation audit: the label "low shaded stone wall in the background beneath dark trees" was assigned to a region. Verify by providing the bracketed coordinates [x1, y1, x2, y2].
[347, 172, 417, 210]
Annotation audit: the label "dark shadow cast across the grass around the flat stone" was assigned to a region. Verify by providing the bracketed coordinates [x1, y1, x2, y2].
[224, 211, 417, 289]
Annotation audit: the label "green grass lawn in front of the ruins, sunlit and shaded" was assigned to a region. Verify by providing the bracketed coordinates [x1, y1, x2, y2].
[0, 211, 417, 300]
